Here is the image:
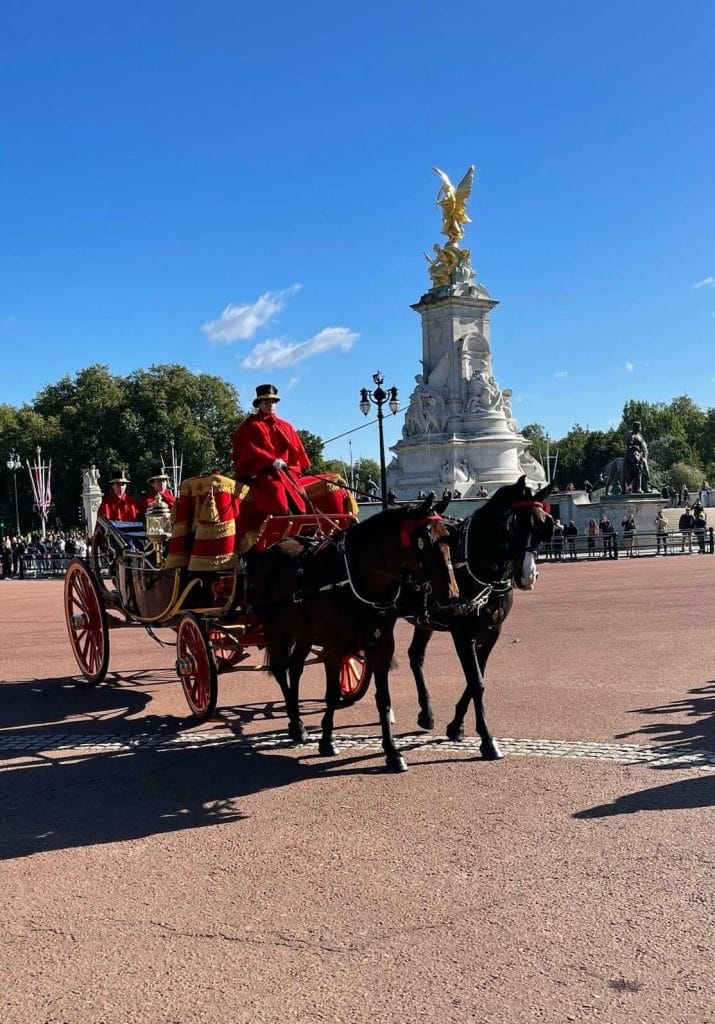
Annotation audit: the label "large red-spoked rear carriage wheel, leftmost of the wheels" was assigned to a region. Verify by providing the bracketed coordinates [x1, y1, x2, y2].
[65, 558, 110, 686]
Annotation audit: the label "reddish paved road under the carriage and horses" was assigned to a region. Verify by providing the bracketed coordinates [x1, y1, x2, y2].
[0, 555, 715, 1024]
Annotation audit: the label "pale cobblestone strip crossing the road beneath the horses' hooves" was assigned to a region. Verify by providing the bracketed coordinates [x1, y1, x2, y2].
[0, 729, 715, 771]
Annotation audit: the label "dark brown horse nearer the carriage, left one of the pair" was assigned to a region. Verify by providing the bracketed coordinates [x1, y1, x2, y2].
[247, 495, 459, 772]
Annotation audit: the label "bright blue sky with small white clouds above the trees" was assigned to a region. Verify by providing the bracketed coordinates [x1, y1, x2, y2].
[0, 0, 715, 466]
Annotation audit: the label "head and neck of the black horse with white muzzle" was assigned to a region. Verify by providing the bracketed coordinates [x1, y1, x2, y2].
[464, 476, 553, 590]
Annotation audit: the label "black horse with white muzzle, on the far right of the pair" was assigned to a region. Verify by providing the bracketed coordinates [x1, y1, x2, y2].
[401, 476, 553, 761]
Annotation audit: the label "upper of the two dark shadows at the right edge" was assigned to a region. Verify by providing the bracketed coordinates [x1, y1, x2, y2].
[616, 680, 715, 757]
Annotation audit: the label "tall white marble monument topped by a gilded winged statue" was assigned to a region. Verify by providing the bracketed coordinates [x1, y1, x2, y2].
[387, 161, 544, 499]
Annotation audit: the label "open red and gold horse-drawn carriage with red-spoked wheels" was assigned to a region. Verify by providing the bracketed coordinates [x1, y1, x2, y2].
[65, 474, 368, 721]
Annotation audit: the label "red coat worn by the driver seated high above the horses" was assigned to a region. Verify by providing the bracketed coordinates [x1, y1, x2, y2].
[230, 413, 310, 515]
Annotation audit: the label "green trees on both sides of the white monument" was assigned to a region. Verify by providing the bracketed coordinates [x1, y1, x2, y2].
[0, 364, 715, 529]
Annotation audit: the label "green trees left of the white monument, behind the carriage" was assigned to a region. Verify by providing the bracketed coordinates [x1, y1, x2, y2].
[0, 364, 379, 531]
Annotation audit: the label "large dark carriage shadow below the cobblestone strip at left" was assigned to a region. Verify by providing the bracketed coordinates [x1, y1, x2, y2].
[0, 743, 320, 860]
